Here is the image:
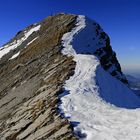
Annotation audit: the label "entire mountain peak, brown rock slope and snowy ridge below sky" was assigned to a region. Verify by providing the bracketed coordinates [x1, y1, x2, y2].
[0, 13, 140, 140]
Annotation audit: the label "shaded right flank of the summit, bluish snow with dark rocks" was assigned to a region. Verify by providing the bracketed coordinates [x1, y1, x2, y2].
[62, 14, 127, 83]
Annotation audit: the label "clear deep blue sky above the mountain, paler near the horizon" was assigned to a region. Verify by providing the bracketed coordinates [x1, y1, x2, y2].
[0, 0, 140, 70]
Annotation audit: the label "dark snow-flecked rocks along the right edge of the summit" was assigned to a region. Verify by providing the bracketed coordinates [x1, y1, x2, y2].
[94, 24, 128, 84]
